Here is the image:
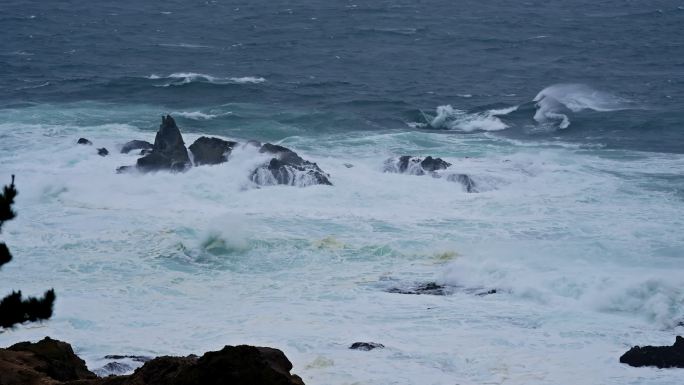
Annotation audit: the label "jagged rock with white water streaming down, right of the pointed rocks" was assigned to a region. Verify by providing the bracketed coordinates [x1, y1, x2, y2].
[251, 143, 332, 187]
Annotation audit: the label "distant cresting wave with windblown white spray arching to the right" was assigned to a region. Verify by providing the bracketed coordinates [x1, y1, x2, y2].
[532, 84, 627, 129]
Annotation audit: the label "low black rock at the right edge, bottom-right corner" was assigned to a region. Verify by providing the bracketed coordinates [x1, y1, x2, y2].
[620, 336, 684, 368]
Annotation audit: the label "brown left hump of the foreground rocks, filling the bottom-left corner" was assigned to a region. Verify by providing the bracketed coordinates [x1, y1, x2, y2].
[0, 337, 97, 385]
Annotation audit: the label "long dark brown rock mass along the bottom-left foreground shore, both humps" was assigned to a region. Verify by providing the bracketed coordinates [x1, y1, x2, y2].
[0, 337, 304, 385]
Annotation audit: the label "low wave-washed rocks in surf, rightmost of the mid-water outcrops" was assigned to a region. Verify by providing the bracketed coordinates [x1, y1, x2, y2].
[385, 155, 479, 193]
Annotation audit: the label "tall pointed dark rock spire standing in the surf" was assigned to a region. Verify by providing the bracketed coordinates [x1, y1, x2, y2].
[137, 115, 190, 172]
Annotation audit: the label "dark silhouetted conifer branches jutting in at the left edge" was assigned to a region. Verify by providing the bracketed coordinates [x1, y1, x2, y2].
[0, 175, 55, 328]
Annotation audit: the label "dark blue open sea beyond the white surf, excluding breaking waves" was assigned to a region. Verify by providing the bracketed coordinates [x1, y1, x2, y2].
[0, 0, 684, 153]
